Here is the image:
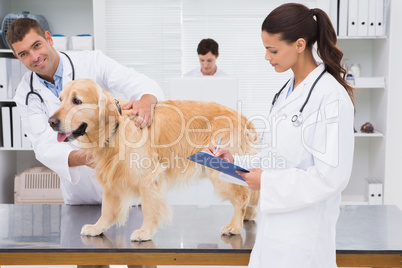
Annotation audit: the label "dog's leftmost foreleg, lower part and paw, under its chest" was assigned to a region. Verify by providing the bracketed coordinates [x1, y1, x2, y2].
[81, 188, 130, 236]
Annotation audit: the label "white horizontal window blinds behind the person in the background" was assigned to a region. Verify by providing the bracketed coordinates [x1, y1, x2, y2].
[99, 0, 319, 128]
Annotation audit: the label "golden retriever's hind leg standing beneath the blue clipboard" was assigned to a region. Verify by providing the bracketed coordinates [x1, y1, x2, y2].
[207, 171, 250, 235]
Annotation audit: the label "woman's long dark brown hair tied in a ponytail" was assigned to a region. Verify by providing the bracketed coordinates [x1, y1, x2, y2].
[261, 3, 353, 101]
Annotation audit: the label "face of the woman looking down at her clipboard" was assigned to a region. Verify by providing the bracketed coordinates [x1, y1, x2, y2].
[261, 31, 299, 73]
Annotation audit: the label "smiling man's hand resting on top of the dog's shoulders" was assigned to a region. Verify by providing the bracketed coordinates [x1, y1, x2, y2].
[123, 94, 157, 128]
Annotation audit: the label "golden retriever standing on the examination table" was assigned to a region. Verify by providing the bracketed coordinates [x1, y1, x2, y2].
[49, 79, 259, 241]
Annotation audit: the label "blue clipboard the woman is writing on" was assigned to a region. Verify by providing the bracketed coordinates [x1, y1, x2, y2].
[187, 152, 250, 181]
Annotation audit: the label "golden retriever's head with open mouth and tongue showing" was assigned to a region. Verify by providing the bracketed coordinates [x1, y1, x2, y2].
[48, 79, 119, 145]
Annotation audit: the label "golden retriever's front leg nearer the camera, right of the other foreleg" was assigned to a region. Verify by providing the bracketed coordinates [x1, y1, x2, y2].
[130, 172, 171, 241]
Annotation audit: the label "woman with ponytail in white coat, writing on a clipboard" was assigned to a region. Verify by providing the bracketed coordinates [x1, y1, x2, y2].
[209, 4, 354, 268]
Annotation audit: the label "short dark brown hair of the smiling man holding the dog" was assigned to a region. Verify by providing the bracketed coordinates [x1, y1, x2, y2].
[6, 18, 46, 51]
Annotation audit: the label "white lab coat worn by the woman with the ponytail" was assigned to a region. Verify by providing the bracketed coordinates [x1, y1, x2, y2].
[226, 65, 354, 268]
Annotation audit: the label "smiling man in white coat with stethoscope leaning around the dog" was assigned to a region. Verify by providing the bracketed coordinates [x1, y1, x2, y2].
[7, 18, 163, 208]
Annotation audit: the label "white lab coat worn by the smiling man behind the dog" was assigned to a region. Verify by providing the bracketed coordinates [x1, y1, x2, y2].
[14, 51, 163, 204]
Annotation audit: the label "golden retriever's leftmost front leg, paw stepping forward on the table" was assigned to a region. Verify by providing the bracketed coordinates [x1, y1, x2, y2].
[81, 188, 122, 236]
